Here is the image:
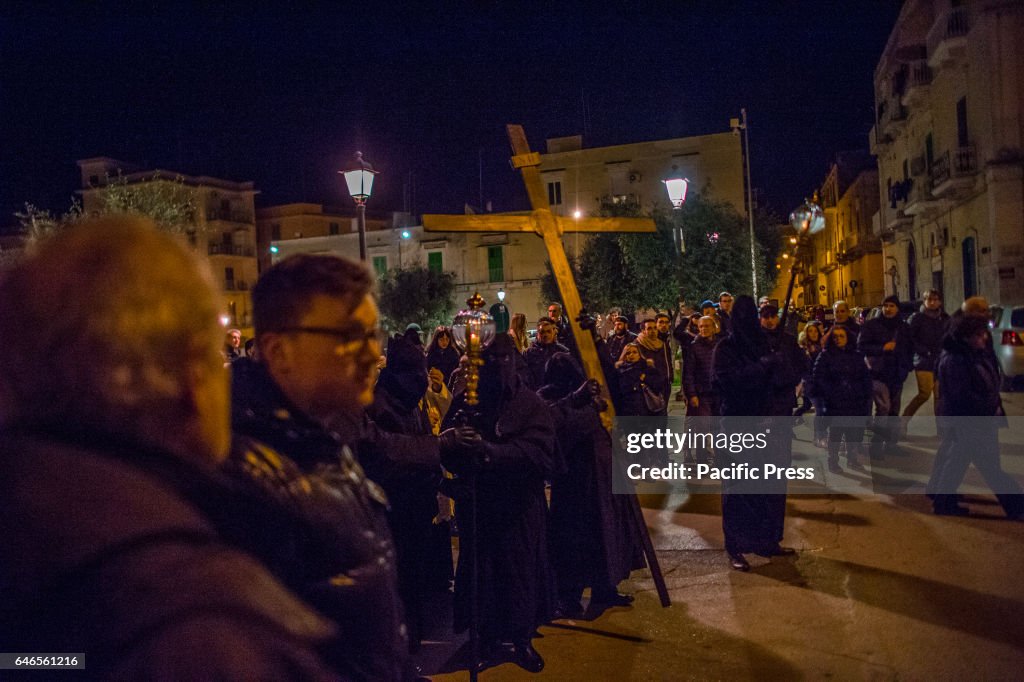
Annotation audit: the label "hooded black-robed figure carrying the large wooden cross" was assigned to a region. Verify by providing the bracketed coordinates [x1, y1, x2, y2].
[538, 353, 644, 617]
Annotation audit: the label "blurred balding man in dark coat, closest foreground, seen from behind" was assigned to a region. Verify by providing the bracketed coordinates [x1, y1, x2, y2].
[0, 217, 340, 680]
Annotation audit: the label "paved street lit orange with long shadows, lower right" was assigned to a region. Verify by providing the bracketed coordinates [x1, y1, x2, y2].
[434, 377, 1024, 680]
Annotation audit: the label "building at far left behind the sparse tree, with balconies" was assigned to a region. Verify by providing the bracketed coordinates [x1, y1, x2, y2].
[78, 157, 258, 336]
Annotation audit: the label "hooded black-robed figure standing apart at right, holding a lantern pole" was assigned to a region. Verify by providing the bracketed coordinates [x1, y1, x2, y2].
[712, 296, 799, 570]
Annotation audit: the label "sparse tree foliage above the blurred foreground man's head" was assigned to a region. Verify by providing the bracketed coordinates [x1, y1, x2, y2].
[14, 172, 198, 244]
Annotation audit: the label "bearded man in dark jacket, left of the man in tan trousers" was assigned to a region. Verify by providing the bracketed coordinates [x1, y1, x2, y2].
[857, 296, 911, 458]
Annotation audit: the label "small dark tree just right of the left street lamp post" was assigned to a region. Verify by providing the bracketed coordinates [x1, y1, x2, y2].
[379, 265, 456, 331]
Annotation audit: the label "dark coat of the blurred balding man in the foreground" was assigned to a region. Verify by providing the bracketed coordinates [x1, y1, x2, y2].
[0, 428, 338, 680]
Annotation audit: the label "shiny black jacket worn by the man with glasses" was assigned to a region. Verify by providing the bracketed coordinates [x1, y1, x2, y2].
[226, 359, 409, 680]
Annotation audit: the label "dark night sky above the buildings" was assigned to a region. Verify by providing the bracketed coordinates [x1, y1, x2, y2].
[0, 0, 900, 227]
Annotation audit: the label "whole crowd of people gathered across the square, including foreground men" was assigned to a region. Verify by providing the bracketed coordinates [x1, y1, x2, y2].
[0, 217, 1024, 680]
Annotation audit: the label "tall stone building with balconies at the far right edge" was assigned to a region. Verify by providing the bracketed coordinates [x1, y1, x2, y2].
[869, 0, 1024, 304]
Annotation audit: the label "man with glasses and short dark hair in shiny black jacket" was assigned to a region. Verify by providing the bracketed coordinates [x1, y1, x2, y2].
[226, 254, 415, 680]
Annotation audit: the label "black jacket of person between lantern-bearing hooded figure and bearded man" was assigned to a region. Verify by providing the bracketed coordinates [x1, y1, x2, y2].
[812, 342, 871, 417]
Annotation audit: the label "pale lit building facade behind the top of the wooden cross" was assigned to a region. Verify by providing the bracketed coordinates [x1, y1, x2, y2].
[541, 132, 746, 216]
